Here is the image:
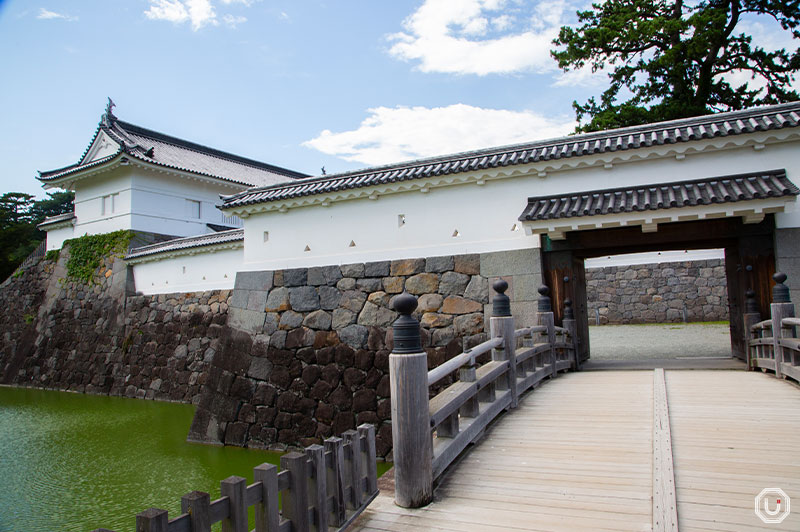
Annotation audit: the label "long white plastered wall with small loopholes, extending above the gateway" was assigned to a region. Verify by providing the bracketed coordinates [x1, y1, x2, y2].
[238, 133, 800, 270]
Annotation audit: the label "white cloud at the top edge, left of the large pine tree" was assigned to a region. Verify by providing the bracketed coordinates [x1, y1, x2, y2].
[388, 0, 571, 76]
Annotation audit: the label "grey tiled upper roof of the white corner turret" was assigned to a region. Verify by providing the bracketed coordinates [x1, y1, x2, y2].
[39, 107, 308, 186]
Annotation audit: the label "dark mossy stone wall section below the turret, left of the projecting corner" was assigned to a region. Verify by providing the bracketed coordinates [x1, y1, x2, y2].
[0, 248, 230, 402]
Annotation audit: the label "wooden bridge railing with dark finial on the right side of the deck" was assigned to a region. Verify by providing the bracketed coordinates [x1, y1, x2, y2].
[745, 273, 800, 381]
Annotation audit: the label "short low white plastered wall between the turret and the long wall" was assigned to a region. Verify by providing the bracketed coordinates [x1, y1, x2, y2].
[128, 248, 242, 295]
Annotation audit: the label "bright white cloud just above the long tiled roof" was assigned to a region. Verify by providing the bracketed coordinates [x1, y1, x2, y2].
[303, 104, 575, 165]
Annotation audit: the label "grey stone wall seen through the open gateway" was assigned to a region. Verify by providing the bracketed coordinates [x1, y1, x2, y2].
[586, 259, 728, 325]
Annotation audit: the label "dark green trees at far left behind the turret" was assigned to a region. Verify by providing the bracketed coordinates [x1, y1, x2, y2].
[0, 192, 75, 280]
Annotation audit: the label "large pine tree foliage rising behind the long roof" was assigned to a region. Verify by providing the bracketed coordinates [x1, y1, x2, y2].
[551, 0, 800, 131]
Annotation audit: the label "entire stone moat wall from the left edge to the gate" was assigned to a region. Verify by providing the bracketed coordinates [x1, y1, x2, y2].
[0, 243, 541, 458]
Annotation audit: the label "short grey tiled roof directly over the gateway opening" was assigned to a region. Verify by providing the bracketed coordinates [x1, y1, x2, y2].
[519, 170, 800, 221]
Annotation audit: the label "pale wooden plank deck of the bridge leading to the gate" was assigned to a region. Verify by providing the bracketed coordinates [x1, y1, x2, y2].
[354, 371, 800, 532]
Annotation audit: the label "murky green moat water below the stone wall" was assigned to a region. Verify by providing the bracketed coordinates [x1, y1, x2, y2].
[0, 387, 288, 532]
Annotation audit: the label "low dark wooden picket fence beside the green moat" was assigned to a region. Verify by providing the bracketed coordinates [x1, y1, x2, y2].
[94, 424, 378, 532]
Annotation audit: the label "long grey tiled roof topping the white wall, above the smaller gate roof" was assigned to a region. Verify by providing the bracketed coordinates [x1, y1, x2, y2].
[223, 102, 800, 208]
